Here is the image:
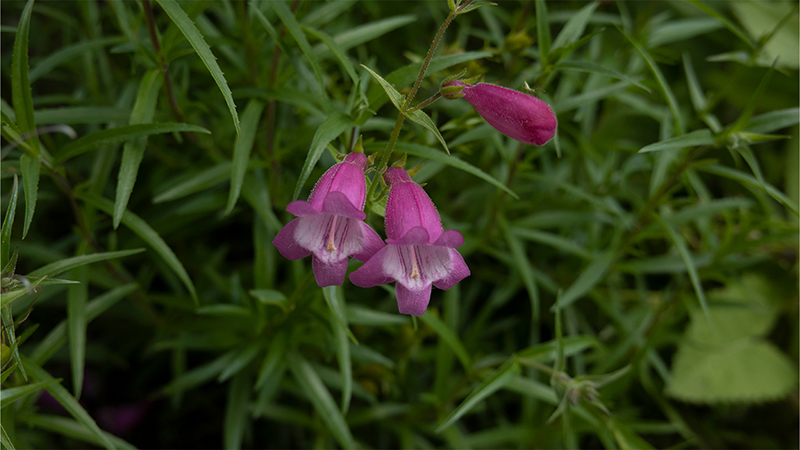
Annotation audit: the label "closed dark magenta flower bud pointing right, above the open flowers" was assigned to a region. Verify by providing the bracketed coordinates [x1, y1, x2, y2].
[442, 80, 558, 145]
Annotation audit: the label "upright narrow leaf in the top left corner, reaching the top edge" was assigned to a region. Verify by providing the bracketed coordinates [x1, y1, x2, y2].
[11, 0, 39, 155]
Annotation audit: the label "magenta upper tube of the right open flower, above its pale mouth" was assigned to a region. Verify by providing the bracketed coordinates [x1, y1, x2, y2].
[383, 167, 442, 240]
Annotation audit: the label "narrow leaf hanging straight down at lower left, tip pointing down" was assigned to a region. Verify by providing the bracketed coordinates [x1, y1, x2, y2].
[67, 266, 89, 398]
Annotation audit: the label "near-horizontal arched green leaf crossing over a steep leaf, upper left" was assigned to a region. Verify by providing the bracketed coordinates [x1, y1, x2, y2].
[56, 123, 211, 164]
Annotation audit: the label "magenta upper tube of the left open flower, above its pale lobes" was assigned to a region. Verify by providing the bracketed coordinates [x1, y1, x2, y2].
[308, 153, 367, 211]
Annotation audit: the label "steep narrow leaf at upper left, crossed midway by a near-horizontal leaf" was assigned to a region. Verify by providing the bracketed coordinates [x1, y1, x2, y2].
[113, 69, 164, 229]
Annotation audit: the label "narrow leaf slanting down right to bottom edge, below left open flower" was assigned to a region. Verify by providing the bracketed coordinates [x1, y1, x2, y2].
[289, 355, 356, 448]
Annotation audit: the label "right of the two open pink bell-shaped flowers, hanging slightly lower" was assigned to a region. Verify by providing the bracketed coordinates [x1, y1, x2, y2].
[350, 167, 469, 316]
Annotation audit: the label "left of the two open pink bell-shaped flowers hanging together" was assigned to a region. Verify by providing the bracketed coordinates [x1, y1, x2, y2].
[272, 153, 383, 287]
